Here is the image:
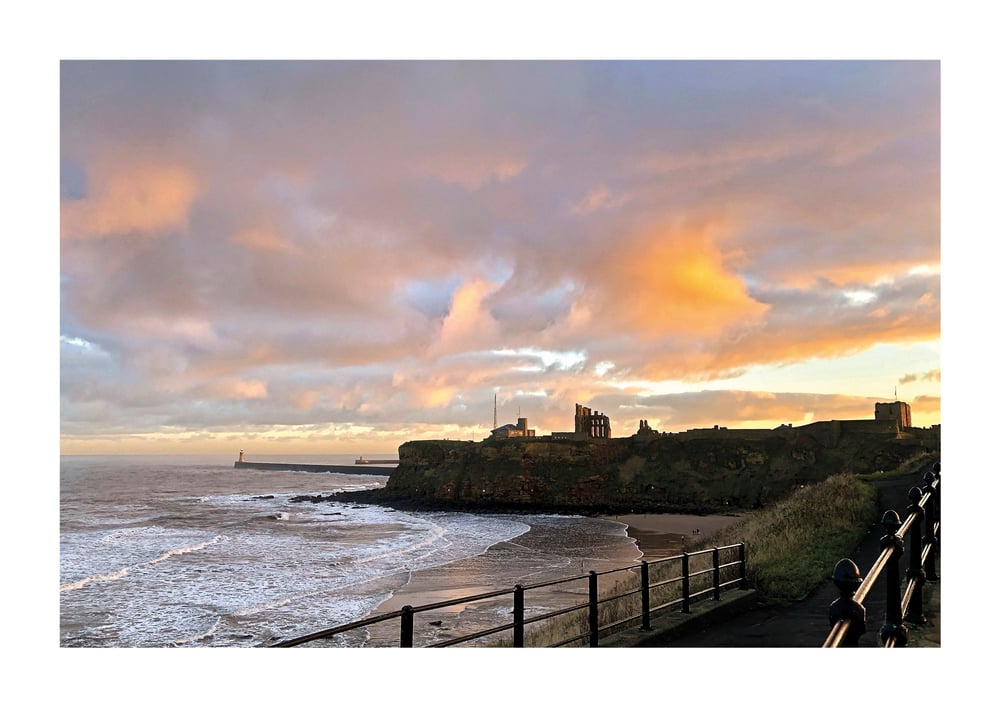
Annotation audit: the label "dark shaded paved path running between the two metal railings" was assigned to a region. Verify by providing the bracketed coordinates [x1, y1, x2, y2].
[643, 468, 941, 648]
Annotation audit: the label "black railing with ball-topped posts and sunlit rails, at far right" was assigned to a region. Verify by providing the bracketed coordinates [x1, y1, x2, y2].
[823, 463, 941, 648]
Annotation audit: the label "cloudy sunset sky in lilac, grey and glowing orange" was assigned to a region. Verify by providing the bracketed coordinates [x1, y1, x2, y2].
[59, 60, 942, 457]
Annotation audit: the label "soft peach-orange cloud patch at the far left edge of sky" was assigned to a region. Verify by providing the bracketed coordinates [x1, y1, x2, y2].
[61, 165, 197, 238]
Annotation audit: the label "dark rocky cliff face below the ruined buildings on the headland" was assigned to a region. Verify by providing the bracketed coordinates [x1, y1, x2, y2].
[381, 430, 926, 512]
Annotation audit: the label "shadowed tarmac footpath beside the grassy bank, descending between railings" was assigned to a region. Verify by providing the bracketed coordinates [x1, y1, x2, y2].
[602, 468, 941, 648]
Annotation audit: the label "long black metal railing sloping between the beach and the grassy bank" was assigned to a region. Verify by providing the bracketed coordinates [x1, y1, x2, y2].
[270, 543, 747, 648]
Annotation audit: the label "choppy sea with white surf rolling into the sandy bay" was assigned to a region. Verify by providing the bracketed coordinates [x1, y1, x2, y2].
[59, 453, 641, 649]
